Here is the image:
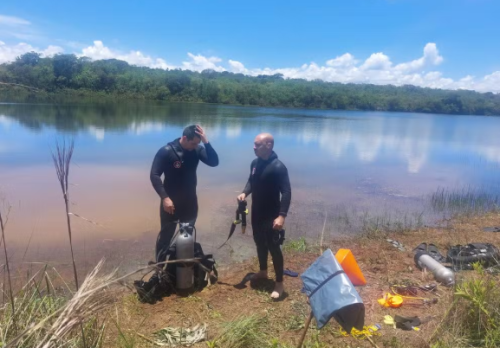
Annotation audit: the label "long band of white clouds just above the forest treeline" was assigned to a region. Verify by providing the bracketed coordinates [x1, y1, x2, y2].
[0, 38, 500, 93]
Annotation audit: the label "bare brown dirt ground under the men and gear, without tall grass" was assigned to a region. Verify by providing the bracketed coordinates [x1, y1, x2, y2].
[100, 214, 500, 347]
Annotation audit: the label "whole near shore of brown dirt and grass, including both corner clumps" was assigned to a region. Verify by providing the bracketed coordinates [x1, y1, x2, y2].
[0, 208, 500, 348]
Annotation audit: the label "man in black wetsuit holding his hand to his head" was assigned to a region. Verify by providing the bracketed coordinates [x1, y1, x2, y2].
[150, 125, 219, 262]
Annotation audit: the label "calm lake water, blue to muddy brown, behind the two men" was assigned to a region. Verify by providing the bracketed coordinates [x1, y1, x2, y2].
[0, 103, 500, 266]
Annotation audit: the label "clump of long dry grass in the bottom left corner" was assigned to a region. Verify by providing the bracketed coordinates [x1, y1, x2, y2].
[0, 261, 117, 348]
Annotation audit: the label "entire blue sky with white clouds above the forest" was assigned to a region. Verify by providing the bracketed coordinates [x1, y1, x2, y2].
[0, 0, 500, 93]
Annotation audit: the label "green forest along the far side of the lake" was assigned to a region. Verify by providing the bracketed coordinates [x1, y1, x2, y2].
[0, 52, 500, 115]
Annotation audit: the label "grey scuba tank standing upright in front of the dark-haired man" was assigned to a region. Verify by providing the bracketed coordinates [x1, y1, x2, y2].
[175, 223, 194, 292]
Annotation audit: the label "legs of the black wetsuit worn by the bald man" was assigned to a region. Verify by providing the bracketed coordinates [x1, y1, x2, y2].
[252, 220, 283, 282]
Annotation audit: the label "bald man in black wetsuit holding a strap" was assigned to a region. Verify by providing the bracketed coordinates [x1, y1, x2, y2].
[237, 133, 292, 299]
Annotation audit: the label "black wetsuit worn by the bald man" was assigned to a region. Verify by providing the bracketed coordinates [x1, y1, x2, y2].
[243, 152, 292, 282]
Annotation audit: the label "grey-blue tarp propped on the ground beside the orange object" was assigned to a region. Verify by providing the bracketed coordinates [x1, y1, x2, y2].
[300, 249, 365, 333]
